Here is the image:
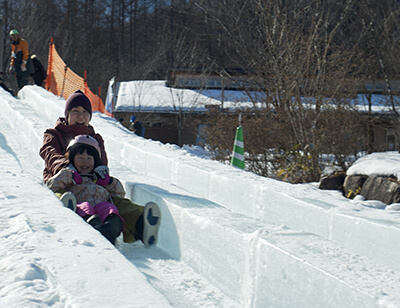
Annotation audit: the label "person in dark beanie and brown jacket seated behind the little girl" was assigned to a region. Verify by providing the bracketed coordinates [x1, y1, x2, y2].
[40, 90, 161, 247]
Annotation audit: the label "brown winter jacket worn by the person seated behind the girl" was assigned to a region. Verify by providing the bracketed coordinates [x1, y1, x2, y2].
[39, 118, 108, 183]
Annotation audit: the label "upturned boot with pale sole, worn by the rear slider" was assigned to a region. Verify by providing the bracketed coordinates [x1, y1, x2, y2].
[138, 202, 161, 248]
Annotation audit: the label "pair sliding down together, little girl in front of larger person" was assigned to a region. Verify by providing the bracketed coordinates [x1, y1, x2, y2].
[40, 90, 161, 247]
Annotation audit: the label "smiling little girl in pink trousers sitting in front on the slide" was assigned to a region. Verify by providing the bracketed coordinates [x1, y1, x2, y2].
[46, 135, 125, 245]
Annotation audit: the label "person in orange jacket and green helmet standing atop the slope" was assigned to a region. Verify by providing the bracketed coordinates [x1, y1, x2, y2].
[9, 29, 33, 90]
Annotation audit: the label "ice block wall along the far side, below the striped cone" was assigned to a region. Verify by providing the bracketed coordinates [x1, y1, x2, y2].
[92, 106, 400, 270]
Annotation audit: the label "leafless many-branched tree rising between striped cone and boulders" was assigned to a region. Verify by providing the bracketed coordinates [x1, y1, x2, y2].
[199, 0, 364, 180]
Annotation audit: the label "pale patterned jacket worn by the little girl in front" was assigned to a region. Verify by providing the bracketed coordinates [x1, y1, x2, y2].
[46, 168, 125, 206]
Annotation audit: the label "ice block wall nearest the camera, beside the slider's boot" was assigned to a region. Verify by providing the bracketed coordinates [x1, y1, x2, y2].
[126, 182, 400, 307]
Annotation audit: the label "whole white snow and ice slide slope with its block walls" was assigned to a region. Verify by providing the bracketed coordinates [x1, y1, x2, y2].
[0, 86, 400, 307]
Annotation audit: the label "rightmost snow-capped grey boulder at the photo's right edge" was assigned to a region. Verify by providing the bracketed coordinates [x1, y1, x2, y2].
[361, 175, 400, 204]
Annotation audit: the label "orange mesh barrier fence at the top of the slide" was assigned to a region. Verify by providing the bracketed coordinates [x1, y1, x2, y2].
[45, 38, 112, 117]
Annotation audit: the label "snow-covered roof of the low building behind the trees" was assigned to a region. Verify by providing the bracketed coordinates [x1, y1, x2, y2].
[109, 80, 400, 113]
